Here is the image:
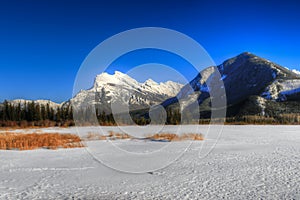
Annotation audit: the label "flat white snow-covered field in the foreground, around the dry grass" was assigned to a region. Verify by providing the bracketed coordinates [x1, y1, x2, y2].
[0, 126, 300, 199]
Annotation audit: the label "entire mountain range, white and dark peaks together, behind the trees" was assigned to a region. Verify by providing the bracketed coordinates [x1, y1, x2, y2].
[3, 52, 300, 123]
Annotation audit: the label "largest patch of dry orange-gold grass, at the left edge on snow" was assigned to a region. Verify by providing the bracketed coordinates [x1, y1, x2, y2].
[0, 132, 83, 150]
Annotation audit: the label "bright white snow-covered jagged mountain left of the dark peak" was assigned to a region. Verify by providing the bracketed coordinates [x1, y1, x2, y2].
[71, 71, 183, 112]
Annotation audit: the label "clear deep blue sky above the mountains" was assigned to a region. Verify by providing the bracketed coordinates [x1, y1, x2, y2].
[0, 0, 300, 102]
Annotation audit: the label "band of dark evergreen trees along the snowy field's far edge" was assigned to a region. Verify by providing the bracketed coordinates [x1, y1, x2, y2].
[0, 101, 300, 127]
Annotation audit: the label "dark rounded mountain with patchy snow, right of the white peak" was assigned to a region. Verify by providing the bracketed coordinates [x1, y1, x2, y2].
[162, 52, 300, 117]
